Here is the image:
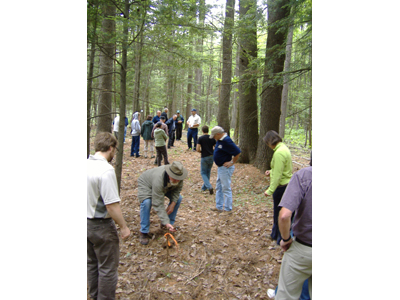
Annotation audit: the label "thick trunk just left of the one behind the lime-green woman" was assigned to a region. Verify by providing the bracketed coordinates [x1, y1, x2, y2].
[239, 0, 258, 163]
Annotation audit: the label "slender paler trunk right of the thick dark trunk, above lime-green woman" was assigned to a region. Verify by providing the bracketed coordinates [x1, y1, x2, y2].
[279, 26, 293, 139]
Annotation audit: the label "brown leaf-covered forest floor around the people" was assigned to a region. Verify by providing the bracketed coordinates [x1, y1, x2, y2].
[87, 131, 310, 300]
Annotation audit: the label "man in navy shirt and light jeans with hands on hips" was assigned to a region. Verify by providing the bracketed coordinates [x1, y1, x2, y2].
[210, 126, 242, 215]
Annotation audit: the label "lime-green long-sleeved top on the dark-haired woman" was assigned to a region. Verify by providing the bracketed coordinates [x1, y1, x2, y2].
[267, 143, 293, 195]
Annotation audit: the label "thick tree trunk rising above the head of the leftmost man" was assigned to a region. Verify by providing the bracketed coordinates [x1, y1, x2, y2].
[97, 2, 115, 134]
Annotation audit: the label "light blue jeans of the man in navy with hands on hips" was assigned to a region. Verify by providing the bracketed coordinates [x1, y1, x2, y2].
[215, 165, 235, 211]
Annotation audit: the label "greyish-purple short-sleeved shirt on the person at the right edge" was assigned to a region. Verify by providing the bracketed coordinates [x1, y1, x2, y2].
[279, 167, 312, 245]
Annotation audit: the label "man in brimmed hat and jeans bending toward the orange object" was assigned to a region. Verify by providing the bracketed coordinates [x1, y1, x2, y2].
[138, 161, 188, 245]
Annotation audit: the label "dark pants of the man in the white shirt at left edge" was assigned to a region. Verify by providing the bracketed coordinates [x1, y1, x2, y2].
[87, 219, 119, 300]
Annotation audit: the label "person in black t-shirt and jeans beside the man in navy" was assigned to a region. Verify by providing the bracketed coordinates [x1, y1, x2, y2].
[196, 125, 216, 195]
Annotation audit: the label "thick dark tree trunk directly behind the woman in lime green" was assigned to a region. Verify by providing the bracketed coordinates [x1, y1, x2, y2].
[255, 0, 290, 172]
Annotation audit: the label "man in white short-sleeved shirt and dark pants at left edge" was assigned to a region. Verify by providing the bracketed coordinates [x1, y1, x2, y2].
[87, 132, 130, 300]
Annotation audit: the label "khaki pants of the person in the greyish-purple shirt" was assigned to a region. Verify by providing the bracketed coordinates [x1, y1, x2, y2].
[275, 241, 312, 300]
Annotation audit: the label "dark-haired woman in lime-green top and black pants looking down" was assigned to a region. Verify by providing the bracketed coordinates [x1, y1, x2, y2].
[263, 130, 293, 245]
